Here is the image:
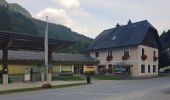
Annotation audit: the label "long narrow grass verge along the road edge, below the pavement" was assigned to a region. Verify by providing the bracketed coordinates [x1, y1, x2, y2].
[0, 83, 87, 95]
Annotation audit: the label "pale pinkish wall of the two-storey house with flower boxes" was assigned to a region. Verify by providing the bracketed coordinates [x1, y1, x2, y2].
[90, 45, 158, 76]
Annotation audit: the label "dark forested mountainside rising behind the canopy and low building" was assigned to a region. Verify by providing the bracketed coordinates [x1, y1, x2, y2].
[0, 6, 93, 53]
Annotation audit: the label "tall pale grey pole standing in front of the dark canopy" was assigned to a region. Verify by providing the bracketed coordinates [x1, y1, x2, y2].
[44, 16, 49, 81]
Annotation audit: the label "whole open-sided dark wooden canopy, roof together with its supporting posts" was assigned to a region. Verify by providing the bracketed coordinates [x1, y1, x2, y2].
[0, 31, 75, 84]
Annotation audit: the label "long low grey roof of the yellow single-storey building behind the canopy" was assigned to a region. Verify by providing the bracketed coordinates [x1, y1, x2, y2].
[0, 50, 99, 63]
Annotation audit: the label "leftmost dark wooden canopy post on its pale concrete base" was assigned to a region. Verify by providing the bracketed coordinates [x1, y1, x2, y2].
[2, 46, 8, 84]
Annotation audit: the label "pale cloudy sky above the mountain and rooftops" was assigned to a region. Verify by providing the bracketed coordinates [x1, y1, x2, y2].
[7, 0, 170, 38]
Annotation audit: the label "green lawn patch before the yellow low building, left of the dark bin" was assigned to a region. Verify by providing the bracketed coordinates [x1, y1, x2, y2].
[52, 76, 84, 81]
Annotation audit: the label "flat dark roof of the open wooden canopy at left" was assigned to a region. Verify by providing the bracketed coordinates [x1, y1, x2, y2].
[0, 31, 75, 52]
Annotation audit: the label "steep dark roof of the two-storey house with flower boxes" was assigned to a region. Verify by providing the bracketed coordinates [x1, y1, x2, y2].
[87, 20, 158, 51]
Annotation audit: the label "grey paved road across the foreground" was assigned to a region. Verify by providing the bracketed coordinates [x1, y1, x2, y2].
[0, 78, 170, 100]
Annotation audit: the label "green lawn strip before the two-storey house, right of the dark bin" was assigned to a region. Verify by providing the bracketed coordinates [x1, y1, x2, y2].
[93, 75, 121, 80]
